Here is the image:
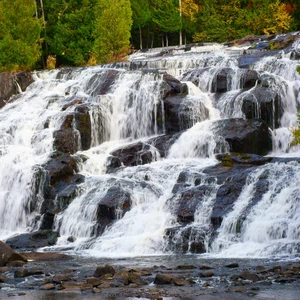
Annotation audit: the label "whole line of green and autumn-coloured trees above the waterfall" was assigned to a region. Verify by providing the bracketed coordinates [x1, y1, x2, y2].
[0, 0, 300, 71]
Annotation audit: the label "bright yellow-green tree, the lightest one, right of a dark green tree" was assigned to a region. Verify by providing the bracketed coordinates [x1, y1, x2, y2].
[93, 0, 132, 63]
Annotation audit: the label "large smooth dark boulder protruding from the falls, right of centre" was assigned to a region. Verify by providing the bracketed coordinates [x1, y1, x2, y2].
[213, 119, 272, 155]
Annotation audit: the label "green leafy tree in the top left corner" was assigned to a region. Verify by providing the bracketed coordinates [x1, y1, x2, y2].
[0, 0, 41, 71]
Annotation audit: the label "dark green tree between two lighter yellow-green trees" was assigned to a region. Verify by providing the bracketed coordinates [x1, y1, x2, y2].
[45, 0, 96, 66]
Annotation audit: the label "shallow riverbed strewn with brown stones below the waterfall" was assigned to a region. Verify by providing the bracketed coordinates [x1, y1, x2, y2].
[0, 243, 300, 300]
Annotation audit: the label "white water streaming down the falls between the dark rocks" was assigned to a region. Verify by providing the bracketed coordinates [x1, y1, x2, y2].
[0, 37, 300, 257]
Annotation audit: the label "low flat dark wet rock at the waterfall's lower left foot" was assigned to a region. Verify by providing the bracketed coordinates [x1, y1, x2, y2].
[7, 230, 59, 249]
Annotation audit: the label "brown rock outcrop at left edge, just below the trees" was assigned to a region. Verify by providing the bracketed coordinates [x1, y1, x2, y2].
[0, 72, 33, 109]
